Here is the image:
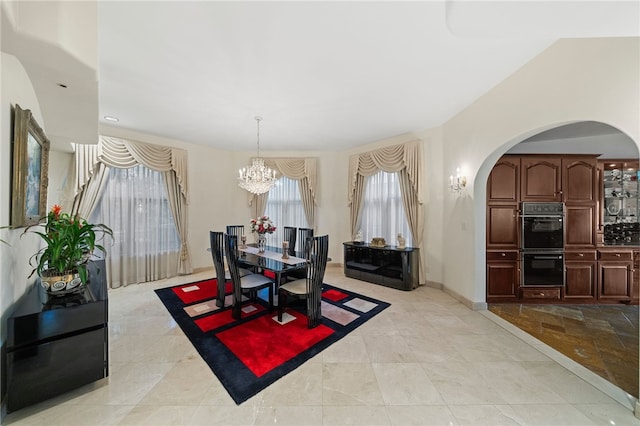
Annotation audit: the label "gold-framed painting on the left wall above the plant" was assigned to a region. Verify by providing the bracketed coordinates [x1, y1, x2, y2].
[11, 104, 51, 227]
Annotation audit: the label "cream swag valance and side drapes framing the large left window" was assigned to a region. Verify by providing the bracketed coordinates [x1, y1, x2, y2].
[73, 136, 193, 282]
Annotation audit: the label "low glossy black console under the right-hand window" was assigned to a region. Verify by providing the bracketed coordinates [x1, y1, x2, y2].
[342, 241, 420, 291]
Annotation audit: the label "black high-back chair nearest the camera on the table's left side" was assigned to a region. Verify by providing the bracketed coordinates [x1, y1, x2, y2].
[224, 234, 274, 319]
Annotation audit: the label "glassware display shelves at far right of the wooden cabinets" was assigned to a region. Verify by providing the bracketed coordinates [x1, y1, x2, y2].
[602, 161, 639, 225]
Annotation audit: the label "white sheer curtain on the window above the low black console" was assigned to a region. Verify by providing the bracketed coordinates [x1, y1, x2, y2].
[360, 171, 413, 246]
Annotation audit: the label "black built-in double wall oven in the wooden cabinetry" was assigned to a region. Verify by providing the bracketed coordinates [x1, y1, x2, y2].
[520, 202, 564, 286]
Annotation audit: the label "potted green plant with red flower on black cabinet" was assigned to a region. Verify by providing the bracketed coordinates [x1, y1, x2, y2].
[23, 204, 113, 292]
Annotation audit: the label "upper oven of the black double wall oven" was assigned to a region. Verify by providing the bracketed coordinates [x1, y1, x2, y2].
[520, 202, 564, 250]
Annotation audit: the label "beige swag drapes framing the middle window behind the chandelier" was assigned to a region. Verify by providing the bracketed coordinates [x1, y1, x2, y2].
[249, 158, 318, 228]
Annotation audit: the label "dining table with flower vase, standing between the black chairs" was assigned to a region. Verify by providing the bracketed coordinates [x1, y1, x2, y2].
[238, 244, 308, 292]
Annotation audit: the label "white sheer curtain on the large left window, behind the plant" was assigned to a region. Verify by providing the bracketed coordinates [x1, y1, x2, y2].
[90, 165, 181, 288]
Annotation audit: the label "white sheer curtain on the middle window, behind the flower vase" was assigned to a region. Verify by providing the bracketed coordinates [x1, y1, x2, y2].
[265, 176, 309, 246]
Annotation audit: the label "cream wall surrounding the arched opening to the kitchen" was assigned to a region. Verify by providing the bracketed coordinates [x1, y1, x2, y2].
[442, 38, 640, 306]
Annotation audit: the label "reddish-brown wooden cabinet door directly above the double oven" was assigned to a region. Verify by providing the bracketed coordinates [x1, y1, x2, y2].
[520, 156, 562, 201]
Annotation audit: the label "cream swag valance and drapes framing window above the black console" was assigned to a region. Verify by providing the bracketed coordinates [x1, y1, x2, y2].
[348, 141, 424, 282]
